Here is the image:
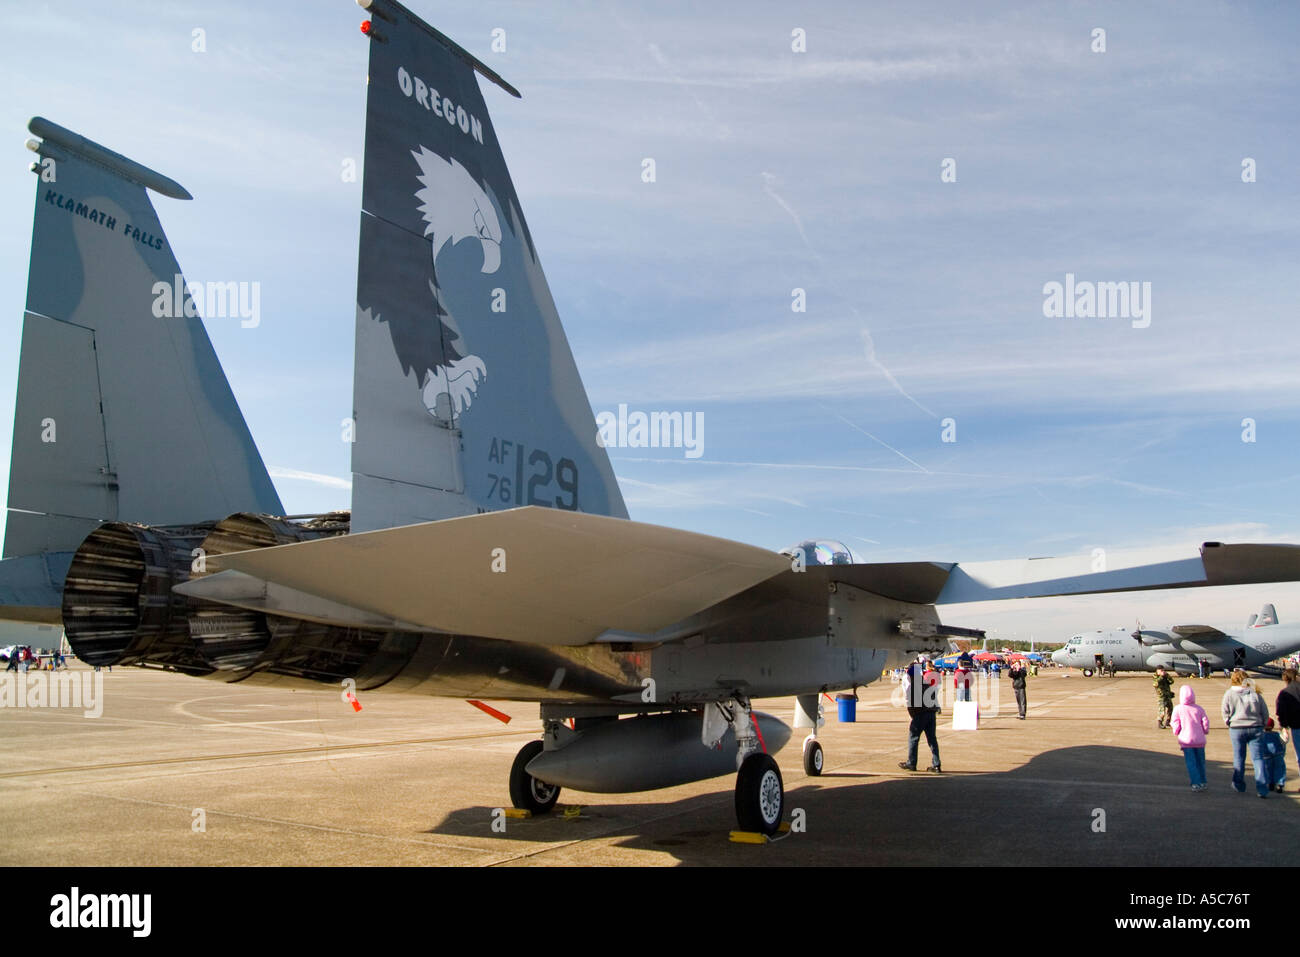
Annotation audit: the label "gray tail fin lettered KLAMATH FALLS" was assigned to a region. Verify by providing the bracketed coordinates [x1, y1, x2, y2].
[0, 117, 282, 615]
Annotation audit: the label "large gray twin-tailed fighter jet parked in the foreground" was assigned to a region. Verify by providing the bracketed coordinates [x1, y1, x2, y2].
[0, 0, 1300, 833]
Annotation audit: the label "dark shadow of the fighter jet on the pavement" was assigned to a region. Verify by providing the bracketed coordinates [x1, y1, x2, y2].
[429, 745, 1300, 866]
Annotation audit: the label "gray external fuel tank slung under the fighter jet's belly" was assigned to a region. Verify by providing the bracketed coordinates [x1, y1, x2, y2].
[527, 711, 790, 794]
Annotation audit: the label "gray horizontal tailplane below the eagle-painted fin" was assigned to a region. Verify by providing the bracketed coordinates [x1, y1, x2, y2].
[178, 506, 789, 645]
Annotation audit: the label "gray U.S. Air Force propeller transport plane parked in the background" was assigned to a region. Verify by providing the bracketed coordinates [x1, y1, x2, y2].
[1052, 605, 1300, 677]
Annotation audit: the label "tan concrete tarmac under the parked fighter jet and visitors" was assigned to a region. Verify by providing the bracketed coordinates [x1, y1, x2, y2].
[0, 666, 1300, 866]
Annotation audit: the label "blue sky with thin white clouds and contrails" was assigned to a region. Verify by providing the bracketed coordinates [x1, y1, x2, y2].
[0, 0, 1300, 637]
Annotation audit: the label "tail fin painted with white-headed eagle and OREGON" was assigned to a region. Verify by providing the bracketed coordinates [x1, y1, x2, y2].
[352, 4, 628, 532]
